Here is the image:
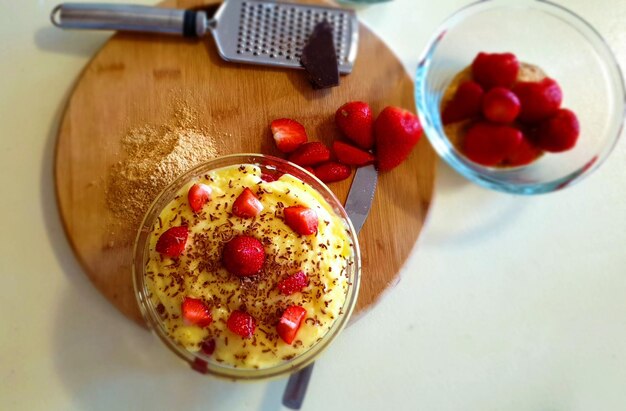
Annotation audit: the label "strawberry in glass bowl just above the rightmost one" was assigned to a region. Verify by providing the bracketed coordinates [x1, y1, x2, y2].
[513, 78, 563, 123]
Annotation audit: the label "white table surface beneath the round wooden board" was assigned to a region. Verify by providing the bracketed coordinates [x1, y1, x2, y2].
[0, 0, 626, 411]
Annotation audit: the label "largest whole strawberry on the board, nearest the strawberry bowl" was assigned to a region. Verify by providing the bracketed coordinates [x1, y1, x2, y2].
[374, 107, 423, 171]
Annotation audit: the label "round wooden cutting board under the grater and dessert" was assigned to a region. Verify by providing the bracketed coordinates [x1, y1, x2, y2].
[55, 0, 436, 324]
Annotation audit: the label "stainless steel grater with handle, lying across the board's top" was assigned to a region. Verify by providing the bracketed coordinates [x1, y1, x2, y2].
[50, 0, 359, 74]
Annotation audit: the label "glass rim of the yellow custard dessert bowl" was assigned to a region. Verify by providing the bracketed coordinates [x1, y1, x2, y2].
[132, 153, 361, 380]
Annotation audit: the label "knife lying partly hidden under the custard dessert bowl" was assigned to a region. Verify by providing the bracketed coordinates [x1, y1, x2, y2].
[283, 164, 378, 410]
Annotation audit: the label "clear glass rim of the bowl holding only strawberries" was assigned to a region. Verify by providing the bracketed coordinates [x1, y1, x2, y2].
[414, 0, 626, 195]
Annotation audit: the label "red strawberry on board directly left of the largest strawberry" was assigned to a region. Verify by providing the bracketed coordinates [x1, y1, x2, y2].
[335, 101, 374, 149]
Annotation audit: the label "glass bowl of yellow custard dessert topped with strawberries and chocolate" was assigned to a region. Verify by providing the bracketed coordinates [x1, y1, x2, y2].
[133, 154, 361, 380]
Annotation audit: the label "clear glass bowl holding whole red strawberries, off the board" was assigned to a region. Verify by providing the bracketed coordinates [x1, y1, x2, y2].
[415, 0, 624, 194]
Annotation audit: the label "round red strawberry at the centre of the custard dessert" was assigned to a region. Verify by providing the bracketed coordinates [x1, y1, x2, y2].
[222, 235, 265, 277]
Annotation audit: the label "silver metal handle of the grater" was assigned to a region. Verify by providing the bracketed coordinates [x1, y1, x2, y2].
[50, 3, 207, 37]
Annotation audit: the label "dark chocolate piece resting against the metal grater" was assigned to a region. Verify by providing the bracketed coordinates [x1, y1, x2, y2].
[300, 20, 339, 89]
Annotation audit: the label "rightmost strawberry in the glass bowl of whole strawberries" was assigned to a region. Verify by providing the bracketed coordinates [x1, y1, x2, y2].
[536, 108, 580, 153]
